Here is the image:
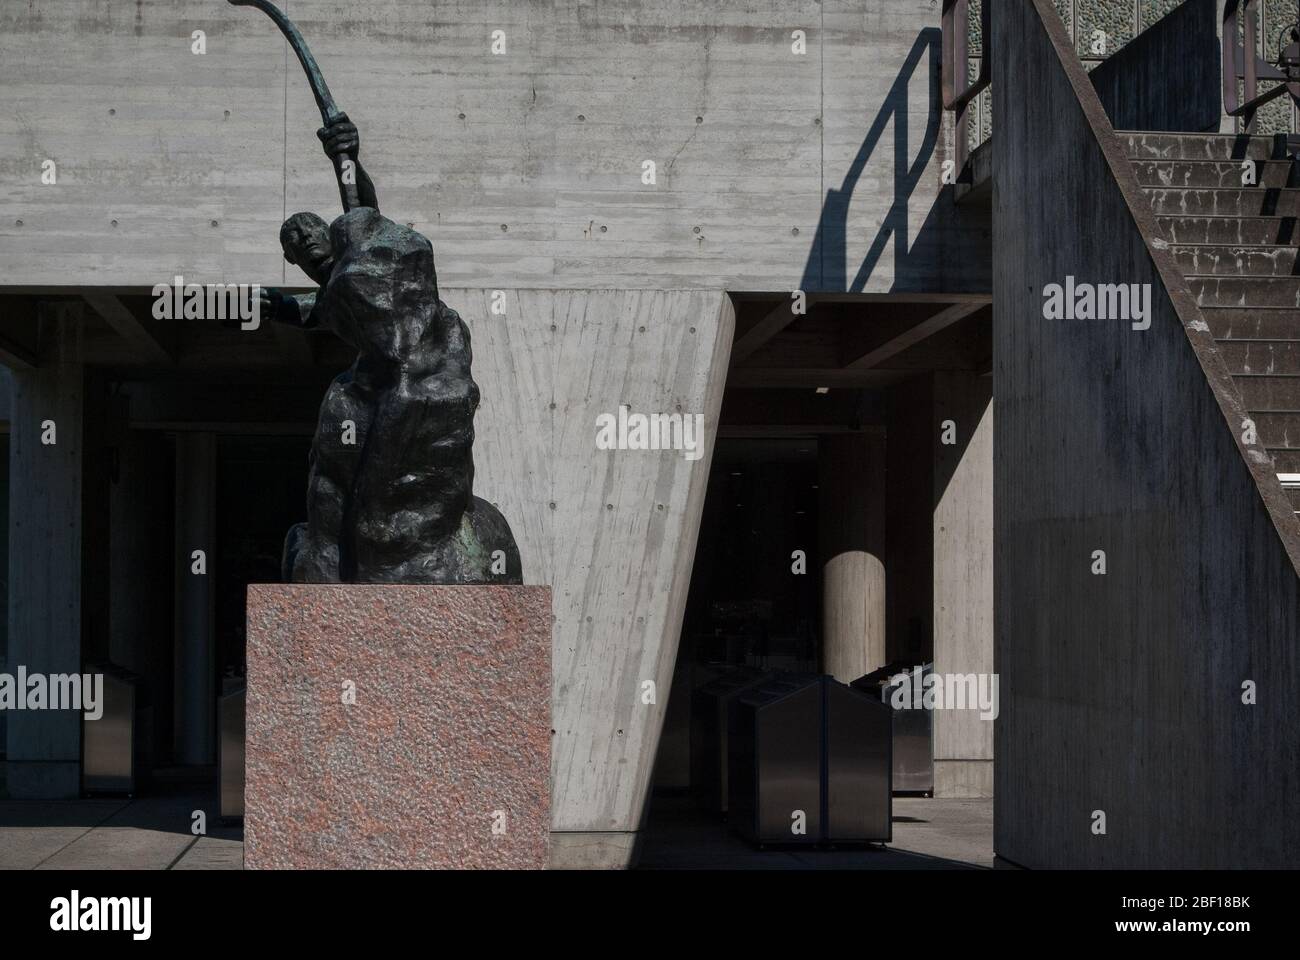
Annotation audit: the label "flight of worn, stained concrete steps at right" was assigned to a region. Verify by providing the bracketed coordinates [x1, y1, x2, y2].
[1119, 133, 1300, 516]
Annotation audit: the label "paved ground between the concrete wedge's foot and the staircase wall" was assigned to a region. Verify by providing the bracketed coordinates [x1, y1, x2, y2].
[640, 797, 993, 870]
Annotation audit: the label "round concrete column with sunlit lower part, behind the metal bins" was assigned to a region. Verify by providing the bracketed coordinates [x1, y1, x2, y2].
[818, 433, 885, 683]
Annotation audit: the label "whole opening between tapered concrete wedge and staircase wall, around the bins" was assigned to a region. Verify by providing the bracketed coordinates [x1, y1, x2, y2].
[640, 294, 992, 868]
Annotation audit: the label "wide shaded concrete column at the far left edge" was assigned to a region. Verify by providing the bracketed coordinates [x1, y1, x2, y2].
[5, 303, 83, 800]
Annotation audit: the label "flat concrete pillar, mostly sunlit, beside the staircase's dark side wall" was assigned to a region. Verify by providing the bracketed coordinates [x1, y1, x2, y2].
[933, 373, 993, 797]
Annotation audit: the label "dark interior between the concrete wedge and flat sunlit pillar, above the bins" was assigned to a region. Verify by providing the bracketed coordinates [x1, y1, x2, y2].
[642, 294, 991, 868]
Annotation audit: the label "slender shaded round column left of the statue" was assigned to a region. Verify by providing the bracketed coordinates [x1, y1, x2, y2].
[173, 433, 217, 765]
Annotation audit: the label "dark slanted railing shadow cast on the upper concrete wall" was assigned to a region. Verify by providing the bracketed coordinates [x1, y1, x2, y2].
[801, 27, 992, 293]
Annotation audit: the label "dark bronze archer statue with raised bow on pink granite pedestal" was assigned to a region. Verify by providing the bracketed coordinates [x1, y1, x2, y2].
[230, 0, 523, 584]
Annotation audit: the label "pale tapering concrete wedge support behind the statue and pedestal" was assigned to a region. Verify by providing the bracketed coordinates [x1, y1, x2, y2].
[442, 289, 735, 866]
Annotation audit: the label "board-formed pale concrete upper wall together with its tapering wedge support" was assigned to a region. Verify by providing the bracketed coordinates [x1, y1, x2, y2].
[0, 0, 991, 865]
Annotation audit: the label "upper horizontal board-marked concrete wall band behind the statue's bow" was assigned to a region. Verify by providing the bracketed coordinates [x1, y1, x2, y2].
[0, 0, 989, 291]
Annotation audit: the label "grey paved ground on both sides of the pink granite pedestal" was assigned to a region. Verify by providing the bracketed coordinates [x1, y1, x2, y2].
[0, 791, 993, 870]
